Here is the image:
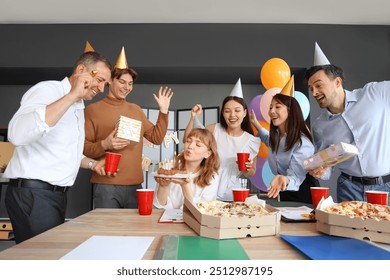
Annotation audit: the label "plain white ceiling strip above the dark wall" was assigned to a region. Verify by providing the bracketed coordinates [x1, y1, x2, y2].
[0, 0, 390, 25]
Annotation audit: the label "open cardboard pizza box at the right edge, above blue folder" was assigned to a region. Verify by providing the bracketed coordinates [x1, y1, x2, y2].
[316, 197, 390, 244]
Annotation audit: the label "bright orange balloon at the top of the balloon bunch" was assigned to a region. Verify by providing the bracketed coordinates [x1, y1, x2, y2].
[260, 57, 291, 90]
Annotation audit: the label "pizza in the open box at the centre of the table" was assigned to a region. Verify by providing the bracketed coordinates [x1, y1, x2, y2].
[196, 200, 270, 217]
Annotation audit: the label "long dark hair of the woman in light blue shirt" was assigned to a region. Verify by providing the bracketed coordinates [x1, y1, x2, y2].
[269, 93, 313, 152]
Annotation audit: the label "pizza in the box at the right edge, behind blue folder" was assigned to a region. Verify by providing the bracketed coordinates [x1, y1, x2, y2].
[324, 201, 390, 221]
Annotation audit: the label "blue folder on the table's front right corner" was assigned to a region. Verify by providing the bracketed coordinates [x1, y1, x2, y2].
[280, 234, 390, 260]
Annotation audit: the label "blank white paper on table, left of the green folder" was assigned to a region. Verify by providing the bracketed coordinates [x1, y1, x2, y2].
[61, 235, 154, 260]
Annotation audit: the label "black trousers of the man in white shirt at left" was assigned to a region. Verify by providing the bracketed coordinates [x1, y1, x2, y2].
[5, 183, 67, 243]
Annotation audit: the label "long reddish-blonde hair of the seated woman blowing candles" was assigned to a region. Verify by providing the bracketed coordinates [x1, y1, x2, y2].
[175, 128, 220, 188]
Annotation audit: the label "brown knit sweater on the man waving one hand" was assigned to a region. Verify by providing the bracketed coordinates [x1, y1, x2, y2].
[84, 97, 168, 185]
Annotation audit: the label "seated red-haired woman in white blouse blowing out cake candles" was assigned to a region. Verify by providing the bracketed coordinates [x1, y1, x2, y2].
[154, 128, 220, 209]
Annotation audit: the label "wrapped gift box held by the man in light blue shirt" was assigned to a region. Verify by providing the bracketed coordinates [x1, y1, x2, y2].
[302, 142, 359, 170]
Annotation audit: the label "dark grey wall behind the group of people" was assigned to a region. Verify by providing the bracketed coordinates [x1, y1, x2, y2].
[0, 24, 390, 217]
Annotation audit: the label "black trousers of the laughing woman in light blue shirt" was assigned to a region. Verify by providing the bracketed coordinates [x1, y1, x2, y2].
[280, 173, 320, 204]
